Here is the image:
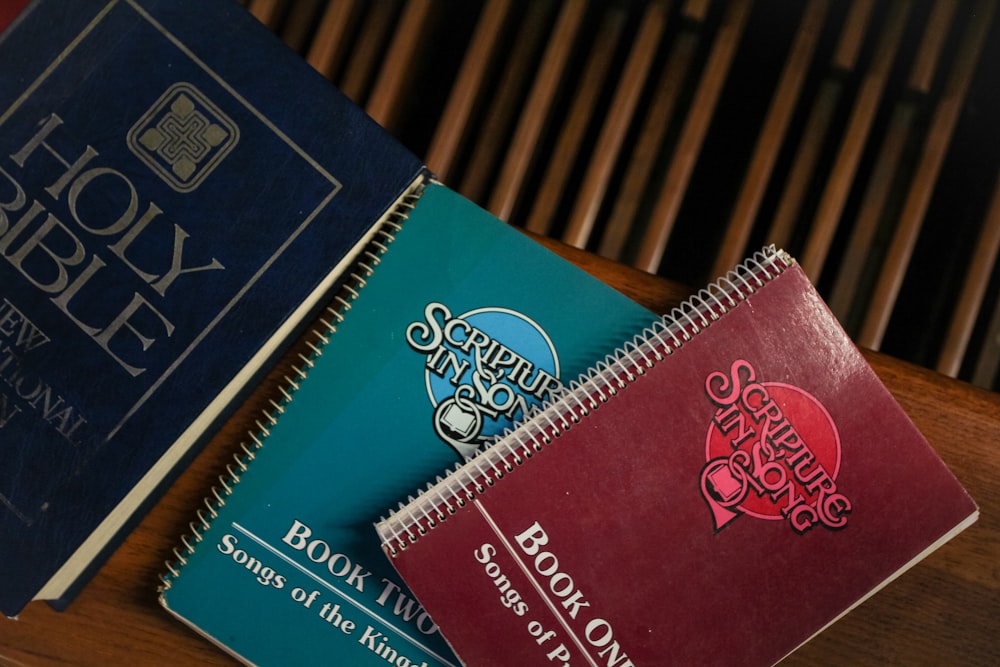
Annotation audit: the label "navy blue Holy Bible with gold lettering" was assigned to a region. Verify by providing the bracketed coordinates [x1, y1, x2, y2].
[0, 0, 423, 615]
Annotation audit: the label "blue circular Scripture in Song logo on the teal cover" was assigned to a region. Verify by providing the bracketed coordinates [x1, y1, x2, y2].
[406, 303, 562, 457]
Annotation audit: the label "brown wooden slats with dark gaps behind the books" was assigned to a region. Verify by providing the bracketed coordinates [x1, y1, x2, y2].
[244, 0, 1000, 391]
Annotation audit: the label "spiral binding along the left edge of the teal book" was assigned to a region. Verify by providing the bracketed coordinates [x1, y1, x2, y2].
[160, 181, 426, 592]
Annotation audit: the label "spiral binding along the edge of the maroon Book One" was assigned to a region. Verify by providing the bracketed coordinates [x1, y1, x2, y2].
[375, 246, 794, 556]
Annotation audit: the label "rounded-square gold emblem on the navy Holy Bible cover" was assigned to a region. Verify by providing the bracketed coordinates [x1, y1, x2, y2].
[128, 82, 240, 192]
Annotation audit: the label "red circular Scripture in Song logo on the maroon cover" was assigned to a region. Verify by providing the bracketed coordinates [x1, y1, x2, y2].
[701, 359, 851, 534]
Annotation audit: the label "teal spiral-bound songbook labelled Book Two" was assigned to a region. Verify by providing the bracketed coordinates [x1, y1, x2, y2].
[161, 184, 654, 666]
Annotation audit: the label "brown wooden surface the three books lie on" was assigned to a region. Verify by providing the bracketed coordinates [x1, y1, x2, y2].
[0, 244, 1000, 666]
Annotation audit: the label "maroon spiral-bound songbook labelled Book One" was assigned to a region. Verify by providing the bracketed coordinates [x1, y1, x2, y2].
[377, 249, 978, 667]
